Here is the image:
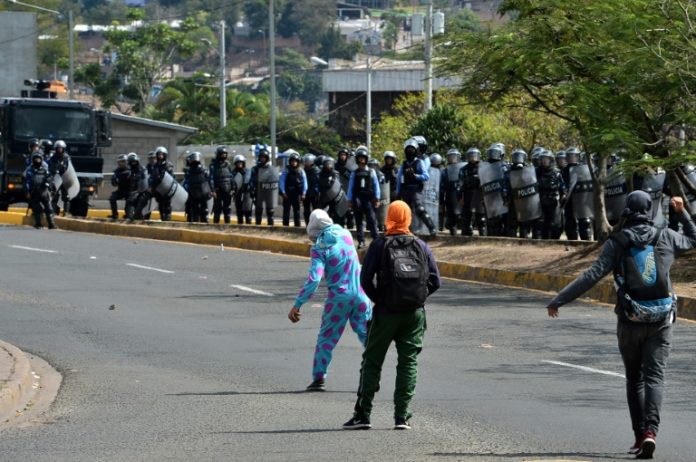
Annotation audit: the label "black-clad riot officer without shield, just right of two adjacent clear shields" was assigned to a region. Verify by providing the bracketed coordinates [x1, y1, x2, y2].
[534, 150, 566, 239]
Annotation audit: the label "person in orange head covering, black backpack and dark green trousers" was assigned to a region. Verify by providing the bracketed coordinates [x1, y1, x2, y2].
[343, 201, 440, 430]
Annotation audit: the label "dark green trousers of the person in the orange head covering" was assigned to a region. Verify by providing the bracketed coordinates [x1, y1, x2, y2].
[355, 309, 425, 419]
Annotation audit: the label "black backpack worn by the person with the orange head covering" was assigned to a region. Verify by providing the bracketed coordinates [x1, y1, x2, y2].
[377, 235, 430, 313]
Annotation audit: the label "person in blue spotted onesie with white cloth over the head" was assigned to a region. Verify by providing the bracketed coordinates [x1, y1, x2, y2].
[288, 209, 372, 391]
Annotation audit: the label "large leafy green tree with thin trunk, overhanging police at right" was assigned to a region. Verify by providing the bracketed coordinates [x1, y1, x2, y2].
[436, 0, 694, 238]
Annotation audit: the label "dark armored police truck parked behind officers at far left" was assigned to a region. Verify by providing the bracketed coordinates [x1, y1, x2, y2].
[0, 81, 111, 216]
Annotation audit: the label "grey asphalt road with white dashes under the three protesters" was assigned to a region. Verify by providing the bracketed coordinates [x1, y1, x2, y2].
[0, 227, 696, 462]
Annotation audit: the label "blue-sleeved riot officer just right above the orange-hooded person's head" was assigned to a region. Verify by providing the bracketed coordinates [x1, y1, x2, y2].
[397, 138, 437, 237]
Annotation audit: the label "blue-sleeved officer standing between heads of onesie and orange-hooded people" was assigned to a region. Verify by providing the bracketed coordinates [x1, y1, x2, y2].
[347, 146, 381, 249]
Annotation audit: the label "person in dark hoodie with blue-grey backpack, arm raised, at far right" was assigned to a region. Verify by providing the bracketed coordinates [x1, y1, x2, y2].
[547, 191, 696, 459]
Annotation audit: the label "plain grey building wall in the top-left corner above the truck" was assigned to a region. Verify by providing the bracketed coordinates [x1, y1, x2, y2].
[0, 11, 38, 96]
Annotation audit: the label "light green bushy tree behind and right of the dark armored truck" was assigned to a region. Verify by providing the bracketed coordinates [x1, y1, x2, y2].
[105, 9, 200, 111]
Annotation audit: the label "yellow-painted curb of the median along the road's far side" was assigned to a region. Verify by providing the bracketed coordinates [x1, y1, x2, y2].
[0, 212, 696, 320]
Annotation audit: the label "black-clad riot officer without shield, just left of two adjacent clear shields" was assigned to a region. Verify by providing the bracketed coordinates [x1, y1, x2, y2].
[459, 148, 488, 236]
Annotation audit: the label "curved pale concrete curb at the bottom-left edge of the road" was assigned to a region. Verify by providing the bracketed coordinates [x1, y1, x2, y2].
[0, 340, 34, 422]
